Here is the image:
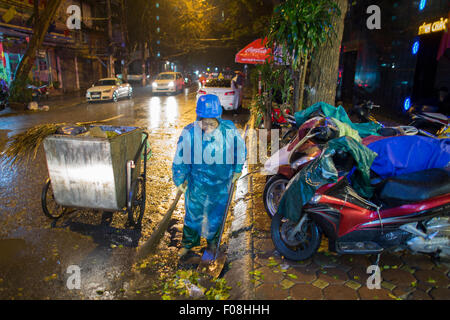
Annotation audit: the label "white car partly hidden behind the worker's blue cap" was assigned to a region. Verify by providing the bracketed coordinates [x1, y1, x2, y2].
[197, 79, 242, 111]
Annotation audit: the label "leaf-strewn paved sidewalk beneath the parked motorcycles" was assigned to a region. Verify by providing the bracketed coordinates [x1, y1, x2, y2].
[232, 112, 450, 300]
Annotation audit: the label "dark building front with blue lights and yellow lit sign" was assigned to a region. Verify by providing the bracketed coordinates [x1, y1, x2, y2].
[337, 0, 450, 112]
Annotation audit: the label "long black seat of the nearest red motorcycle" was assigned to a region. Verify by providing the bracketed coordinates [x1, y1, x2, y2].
[375, 167, 450, 207]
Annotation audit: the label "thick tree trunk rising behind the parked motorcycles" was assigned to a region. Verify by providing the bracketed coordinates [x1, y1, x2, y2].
[305, 0, 347, 106]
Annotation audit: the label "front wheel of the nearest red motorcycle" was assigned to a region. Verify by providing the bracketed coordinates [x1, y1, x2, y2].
[270, 214, 322, 261]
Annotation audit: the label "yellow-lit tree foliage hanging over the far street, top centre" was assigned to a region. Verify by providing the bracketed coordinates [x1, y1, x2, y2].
[133, 0, 273, 58]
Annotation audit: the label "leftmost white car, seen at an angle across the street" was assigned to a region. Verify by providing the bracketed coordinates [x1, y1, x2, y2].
[86, 78, 133, 102]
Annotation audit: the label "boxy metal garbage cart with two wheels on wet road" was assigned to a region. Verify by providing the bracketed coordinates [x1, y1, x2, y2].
[41, 126, 149, 227]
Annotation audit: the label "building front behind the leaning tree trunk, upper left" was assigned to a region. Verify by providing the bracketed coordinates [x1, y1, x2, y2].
[0, 0, 121, 92]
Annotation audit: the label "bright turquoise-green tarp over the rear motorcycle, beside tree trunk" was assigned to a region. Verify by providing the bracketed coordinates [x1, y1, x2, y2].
[295, 102, 381, 138]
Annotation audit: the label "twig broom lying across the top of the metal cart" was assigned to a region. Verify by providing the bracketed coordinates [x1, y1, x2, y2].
[2, 116, 125, 165]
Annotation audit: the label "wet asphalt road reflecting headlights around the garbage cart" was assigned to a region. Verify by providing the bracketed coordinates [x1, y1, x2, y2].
[0, 88, 249, 299]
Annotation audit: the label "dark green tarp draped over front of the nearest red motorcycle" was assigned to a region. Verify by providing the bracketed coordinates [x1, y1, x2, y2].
[277, 137, 377, 221]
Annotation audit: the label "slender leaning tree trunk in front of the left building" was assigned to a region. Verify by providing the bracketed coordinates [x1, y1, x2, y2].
[11, 0, 62, 97]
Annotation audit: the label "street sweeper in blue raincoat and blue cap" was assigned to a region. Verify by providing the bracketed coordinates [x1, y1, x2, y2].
[172, 95, 247, 258]
